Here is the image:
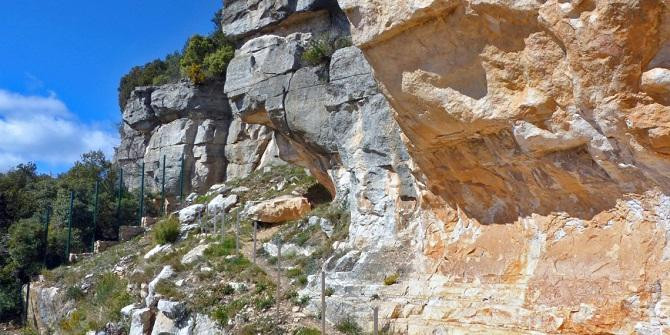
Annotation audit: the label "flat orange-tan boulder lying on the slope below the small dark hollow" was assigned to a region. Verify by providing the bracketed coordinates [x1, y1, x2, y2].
[245, 195, 311, 223]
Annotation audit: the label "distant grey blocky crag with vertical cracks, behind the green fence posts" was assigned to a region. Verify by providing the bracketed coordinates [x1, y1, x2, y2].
[115, 81, 281, 196]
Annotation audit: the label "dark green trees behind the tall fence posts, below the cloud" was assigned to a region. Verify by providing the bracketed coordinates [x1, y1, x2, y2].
[0, 151, 137, 321]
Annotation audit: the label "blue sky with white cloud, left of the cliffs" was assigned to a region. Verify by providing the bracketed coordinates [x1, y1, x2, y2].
[0, 0, 222, 173]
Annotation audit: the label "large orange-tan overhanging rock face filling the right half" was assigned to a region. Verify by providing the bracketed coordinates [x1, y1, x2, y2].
[330, 0, 670, 334]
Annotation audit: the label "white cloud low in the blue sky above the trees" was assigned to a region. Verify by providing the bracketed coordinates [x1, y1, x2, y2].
[0, 89, 119, 171]
